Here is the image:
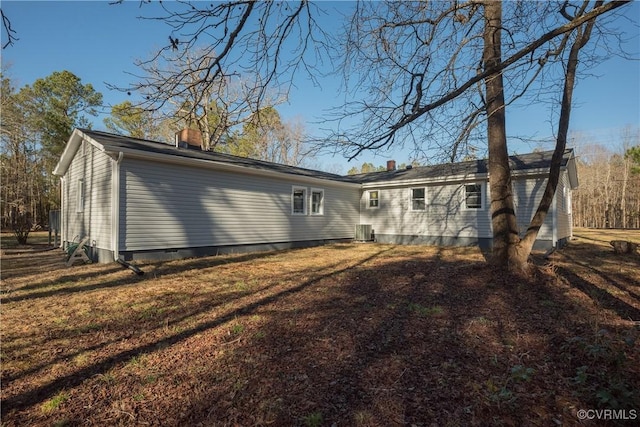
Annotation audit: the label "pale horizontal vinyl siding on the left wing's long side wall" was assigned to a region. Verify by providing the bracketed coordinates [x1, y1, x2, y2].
[119, 156, 360, 251]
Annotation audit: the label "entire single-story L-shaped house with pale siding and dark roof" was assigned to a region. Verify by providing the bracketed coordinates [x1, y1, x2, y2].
[54, 129, 577, 262]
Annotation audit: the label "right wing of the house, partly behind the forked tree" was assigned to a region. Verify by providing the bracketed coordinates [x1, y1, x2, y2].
[353, 149, 578, 249]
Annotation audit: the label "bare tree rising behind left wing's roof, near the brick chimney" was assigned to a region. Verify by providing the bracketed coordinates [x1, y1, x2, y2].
[112, 1, 322, 150]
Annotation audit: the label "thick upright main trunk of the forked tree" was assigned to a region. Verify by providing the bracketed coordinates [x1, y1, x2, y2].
[483, 1, 528, 270]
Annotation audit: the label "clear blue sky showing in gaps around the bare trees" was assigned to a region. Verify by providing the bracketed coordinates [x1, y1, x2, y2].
[1, 0, 640, 173]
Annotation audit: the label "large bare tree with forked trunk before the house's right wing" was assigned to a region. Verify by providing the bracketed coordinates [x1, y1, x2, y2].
[335, 1, 623, 271]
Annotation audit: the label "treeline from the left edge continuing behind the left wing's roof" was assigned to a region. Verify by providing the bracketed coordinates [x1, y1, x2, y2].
[0, 71, 312, 239]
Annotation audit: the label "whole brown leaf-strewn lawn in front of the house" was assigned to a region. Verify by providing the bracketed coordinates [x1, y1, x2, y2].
[1, 230, 640, 426]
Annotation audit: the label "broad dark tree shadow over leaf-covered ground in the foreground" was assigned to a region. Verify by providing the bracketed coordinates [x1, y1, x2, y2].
[2, 245, 640, 426]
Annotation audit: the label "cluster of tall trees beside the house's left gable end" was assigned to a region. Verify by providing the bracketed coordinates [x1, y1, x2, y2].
[0, 71, 102, 237]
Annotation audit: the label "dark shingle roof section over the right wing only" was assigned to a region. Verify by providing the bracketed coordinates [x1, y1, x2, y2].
[352, 149, 573, 184]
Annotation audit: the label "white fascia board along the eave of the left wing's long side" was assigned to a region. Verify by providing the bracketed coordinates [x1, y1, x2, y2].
[107, 147, 360, 188]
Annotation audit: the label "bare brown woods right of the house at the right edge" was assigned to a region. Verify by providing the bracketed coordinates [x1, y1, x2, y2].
[573, 136, 640, 228]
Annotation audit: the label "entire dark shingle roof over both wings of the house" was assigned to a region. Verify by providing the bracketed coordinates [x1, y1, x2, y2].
[80, 129, 573, 184]
